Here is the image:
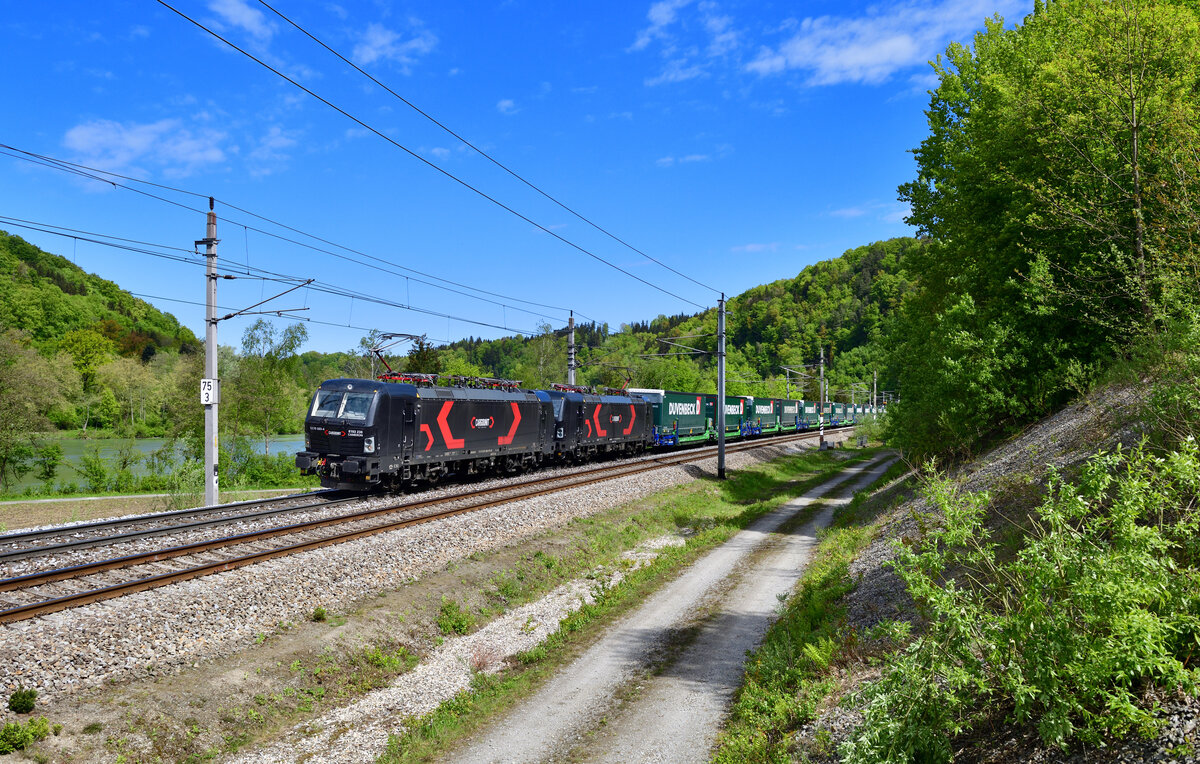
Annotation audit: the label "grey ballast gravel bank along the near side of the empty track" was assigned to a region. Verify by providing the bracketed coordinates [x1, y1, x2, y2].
[0, 432, 848, 703]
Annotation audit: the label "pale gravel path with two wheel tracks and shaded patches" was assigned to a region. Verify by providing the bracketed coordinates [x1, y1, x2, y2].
[452, 450, 887, 763]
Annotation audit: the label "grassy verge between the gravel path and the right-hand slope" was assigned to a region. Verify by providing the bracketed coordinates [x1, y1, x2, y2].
[714, 462, 907, 763]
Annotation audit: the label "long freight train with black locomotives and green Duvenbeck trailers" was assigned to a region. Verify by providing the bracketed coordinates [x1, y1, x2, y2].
[295, 374, 875, 491]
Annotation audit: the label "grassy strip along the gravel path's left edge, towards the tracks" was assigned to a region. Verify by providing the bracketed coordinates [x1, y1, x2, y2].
[380, 450, 876, 763]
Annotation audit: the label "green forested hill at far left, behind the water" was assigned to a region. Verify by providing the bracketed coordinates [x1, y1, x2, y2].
[0, 230, 200, 360]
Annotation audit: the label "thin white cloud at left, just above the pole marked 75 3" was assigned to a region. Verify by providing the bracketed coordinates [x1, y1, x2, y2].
[62, 119, 228, 176]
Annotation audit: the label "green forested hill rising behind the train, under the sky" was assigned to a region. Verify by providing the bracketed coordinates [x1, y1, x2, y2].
[441, 239, 925, 401]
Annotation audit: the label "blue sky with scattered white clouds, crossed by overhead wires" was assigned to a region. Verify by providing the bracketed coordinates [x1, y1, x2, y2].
[0, 0, 1032, 351]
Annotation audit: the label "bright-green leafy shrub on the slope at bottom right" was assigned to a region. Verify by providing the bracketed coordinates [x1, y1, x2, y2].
[841, 439, 1200, 764]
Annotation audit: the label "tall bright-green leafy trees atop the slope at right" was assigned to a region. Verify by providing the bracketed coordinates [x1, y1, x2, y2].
[889, 0, 1200, 452]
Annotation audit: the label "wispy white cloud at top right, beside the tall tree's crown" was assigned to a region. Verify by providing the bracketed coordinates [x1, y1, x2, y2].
[745, 0, 1027, 85]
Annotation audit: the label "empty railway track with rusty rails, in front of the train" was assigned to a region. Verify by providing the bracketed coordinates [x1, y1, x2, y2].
[0, 432, 849, 624]
